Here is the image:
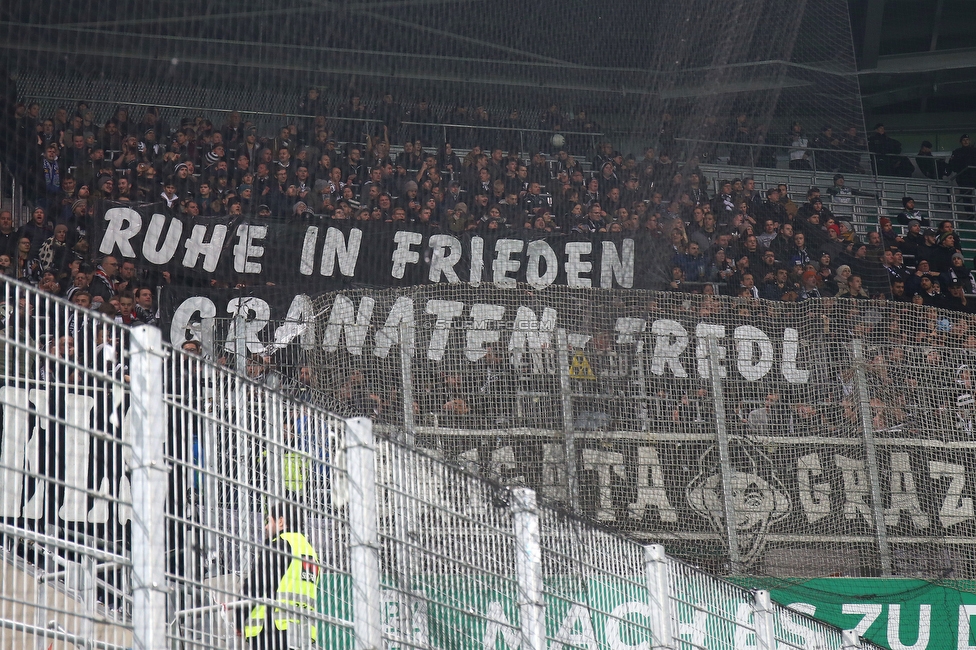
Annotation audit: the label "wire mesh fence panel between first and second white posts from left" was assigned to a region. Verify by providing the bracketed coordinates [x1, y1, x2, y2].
[166, 350, 352, 648]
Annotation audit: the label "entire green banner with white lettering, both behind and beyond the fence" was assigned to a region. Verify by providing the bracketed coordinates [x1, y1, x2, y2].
[319, 574, 976, 650]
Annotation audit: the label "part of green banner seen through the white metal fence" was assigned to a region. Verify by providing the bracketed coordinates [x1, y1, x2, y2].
[318, 574, 856, 650]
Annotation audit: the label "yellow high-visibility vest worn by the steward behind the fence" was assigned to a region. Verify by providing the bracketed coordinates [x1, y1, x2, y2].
[244, 533, 319, 643]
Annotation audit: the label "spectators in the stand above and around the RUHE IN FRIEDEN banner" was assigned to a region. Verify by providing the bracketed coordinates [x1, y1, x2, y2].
[0, 91, 976, 322]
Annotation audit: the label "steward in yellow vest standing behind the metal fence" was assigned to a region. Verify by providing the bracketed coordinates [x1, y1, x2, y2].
[243, 507, 319, 650]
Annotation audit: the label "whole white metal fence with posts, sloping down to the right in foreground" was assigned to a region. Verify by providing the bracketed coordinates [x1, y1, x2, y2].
[0, 274, 884, 650]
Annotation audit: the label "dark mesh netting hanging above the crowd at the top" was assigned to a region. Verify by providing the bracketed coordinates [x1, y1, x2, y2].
[0, 0, 864, 171]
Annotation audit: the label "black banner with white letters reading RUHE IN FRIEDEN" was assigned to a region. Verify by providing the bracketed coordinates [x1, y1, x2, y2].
[92, 202, 656, 291]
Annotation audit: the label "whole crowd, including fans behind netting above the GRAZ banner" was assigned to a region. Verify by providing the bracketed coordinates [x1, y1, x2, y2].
[0, 97, 976, 498]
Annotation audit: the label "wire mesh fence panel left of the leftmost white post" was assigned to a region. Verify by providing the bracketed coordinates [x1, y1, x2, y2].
[0, 283, 132, 650]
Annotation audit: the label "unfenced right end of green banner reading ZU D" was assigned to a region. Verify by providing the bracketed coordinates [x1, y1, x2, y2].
[736, 578, 976, 650]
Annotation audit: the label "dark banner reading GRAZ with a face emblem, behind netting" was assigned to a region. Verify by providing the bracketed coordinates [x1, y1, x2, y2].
[431, 431, 976, 576]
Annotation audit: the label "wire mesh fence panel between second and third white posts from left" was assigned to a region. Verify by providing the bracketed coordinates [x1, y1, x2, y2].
[376, 432, 519, 648]
